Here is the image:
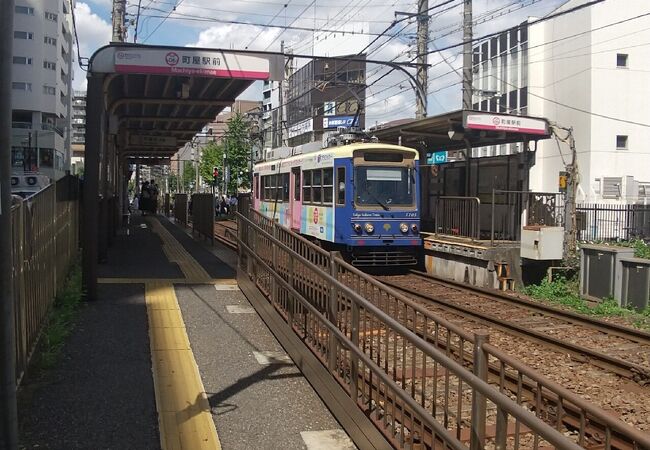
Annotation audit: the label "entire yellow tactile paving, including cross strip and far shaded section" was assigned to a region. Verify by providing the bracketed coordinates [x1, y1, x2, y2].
[98, 219, 230, 450]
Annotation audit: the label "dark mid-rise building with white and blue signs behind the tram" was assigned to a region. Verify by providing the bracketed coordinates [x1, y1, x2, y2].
[283, 55, 366, 147]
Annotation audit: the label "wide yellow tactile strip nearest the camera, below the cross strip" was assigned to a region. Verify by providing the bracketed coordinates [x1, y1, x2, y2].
[145, 280, 221, 450]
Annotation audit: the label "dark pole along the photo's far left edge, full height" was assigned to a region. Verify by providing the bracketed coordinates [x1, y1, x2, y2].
[0, 0, 22, 450]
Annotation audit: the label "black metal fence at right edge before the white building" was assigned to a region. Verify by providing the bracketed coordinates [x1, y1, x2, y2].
[576, 203, 650, 242]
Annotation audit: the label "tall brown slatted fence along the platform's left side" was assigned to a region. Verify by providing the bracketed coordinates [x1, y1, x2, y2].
[11, 176, 79, 385]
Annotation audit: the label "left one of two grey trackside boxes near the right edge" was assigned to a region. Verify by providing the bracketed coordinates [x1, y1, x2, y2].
[580, 245, 634, 304]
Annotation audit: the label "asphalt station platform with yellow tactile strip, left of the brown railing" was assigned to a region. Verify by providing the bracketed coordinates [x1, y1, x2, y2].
[19, 216, 355, 450]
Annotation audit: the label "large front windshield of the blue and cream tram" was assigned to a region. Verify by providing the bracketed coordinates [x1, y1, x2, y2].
[354, 166, 415, 210]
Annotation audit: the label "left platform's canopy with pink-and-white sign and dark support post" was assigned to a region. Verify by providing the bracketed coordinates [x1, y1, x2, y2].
[83, 43, 284, 298]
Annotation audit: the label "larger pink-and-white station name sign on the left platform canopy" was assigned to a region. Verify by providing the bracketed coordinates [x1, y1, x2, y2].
[115, 48, 270, 80]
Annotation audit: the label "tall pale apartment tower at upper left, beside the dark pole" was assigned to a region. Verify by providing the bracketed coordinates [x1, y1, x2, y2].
[11, 0, 74, 179]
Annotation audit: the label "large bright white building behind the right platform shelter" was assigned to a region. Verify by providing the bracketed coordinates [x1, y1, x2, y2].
[473, 0, 650, 203]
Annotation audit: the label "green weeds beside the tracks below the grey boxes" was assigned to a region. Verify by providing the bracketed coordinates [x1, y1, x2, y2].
[524, 277, 650, 330]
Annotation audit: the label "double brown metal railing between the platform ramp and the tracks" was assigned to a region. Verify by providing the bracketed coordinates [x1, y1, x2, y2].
[238, 212, 650, 449]
